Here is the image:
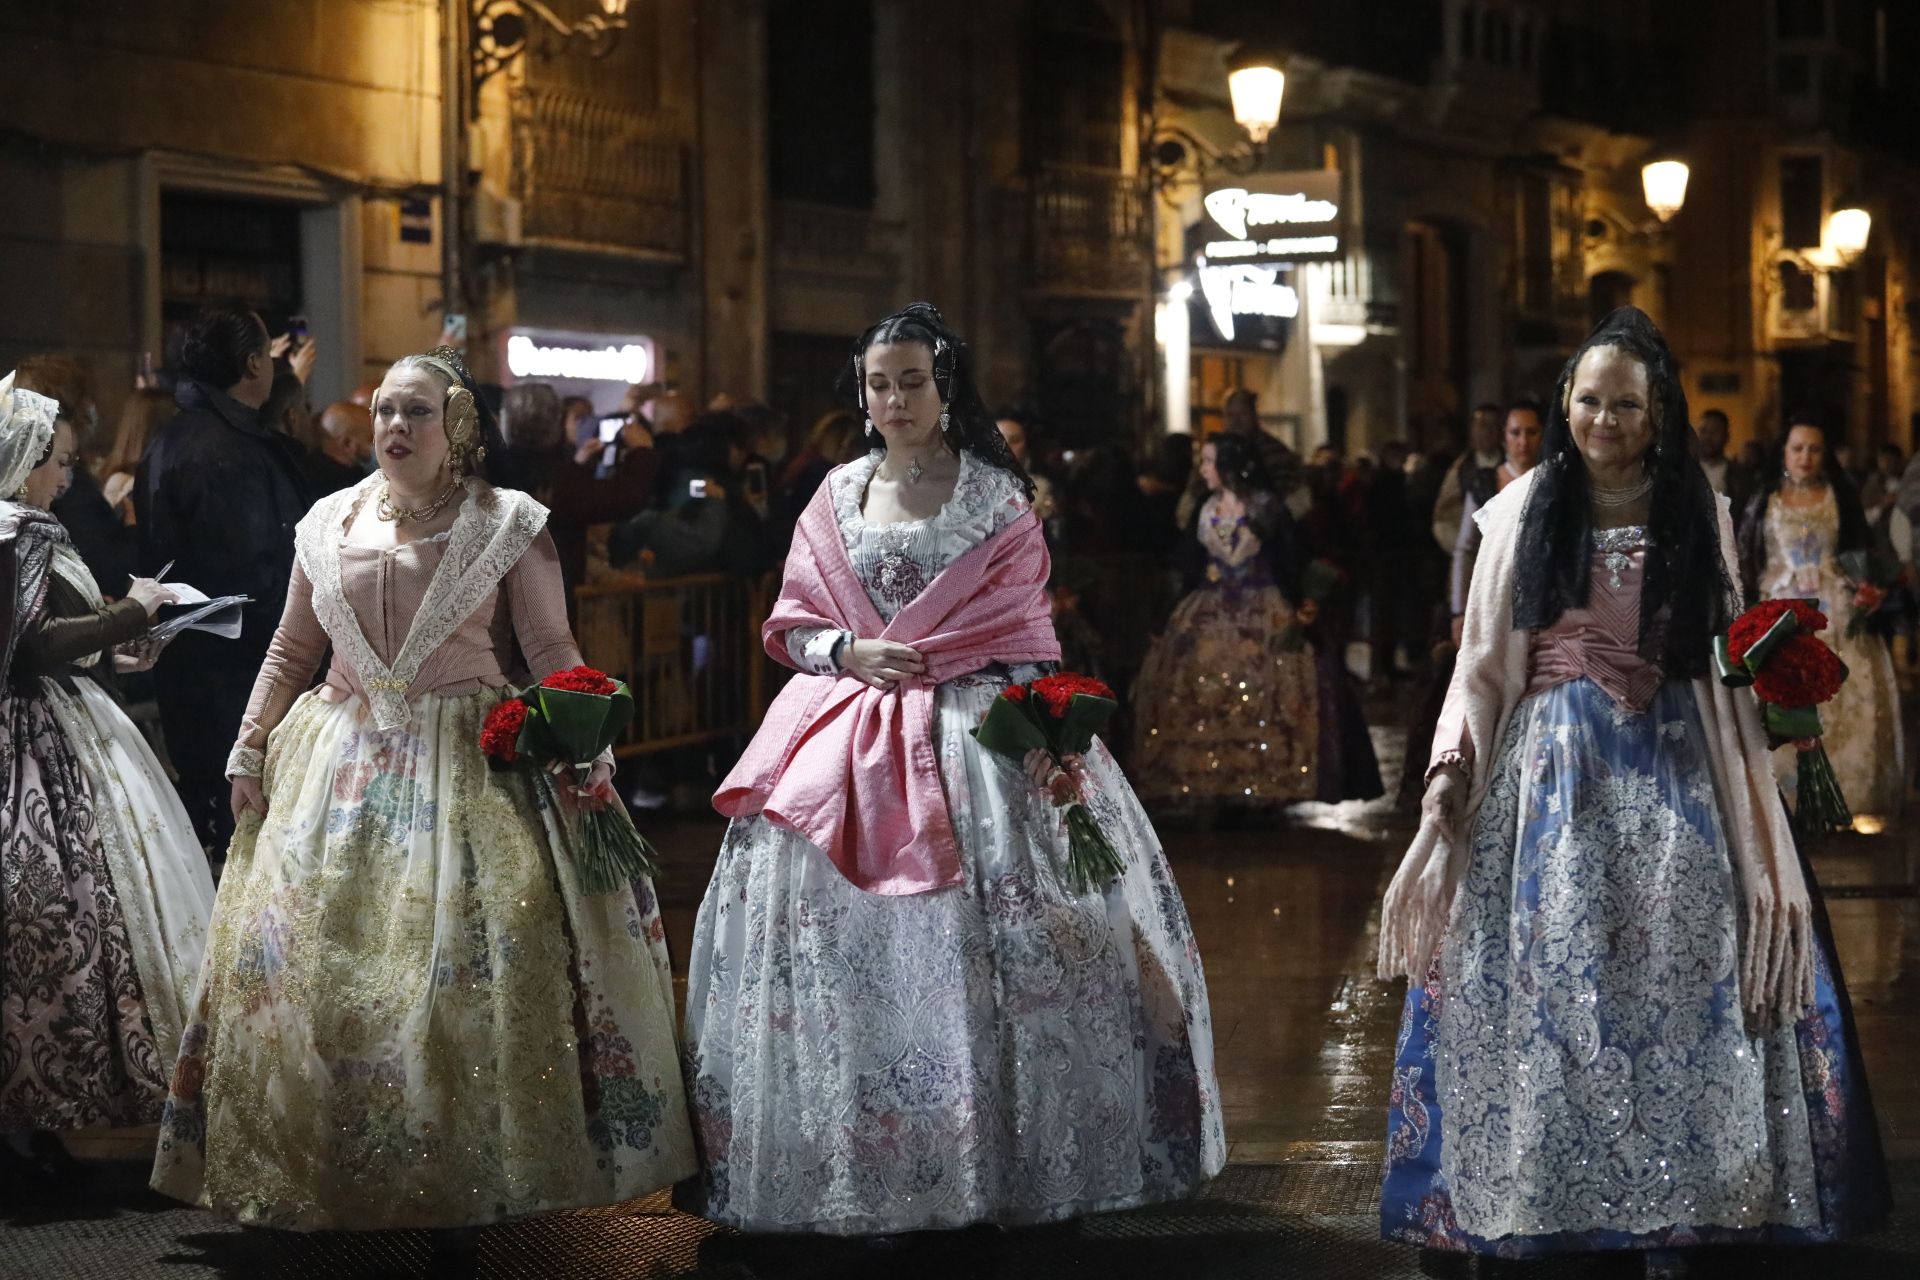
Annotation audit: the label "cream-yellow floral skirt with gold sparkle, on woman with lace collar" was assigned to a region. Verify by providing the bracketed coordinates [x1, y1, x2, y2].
[154, 691, 695, 1228]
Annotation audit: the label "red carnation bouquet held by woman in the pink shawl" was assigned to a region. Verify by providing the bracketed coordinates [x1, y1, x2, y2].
[973, 674, 1127, 892]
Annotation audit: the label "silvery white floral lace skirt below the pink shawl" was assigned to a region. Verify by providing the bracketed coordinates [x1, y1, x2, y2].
[685, 677, 1227, 1234]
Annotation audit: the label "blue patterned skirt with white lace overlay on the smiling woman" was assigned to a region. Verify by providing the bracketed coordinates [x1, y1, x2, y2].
[1380, 679, 1887, 1257]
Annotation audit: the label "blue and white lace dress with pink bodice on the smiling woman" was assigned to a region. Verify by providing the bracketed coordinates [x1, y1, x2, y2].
[1380, 482, 1885, 1257]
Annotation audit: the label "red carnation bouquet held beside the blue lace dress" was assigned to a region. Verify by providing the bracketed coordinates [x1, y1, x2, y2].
[1713, 601, 1853, 833]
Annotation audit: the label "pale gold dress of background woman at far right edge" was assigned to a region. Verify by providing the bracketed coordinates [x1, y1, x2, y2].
[1759, 487, 1907, 818]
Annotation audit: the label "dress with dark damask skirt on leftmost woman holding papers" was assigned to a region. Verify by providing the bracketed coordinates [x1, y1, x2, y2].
[0, 498, 213, 1132]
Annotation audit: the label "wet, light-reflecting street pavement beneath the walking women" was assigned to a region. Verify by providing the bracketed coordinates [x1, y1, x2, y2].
[0, 741, 1920, 1280]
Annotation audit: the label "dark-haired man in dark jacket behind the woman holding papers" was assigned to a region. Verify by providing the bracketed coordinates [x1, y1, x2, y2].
[134, 307, 309, 854]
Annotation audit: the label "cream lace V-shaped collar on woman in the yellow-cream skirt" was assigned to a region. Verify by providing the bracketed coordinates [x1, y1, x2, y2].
[294, 472, 547, 731]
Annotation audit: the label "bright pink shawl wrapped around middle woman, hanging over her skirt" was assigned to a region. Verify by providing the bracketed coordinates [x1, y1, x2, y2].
[714, 466, 1060, 894]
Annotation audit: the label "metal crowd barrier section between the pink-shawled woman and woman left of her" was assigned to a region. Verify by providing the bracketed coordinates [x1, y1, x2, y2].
[576, 574, 776, 756]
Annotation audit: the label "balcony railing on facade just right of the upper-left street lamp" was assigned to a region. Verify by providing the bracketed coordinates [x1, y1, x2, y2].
[513, 86, 687, 259]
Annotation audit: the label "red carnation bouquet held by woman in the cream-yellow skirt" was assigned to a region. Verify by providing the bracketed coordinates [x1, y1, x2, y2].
[480, 666, 659, 894]
